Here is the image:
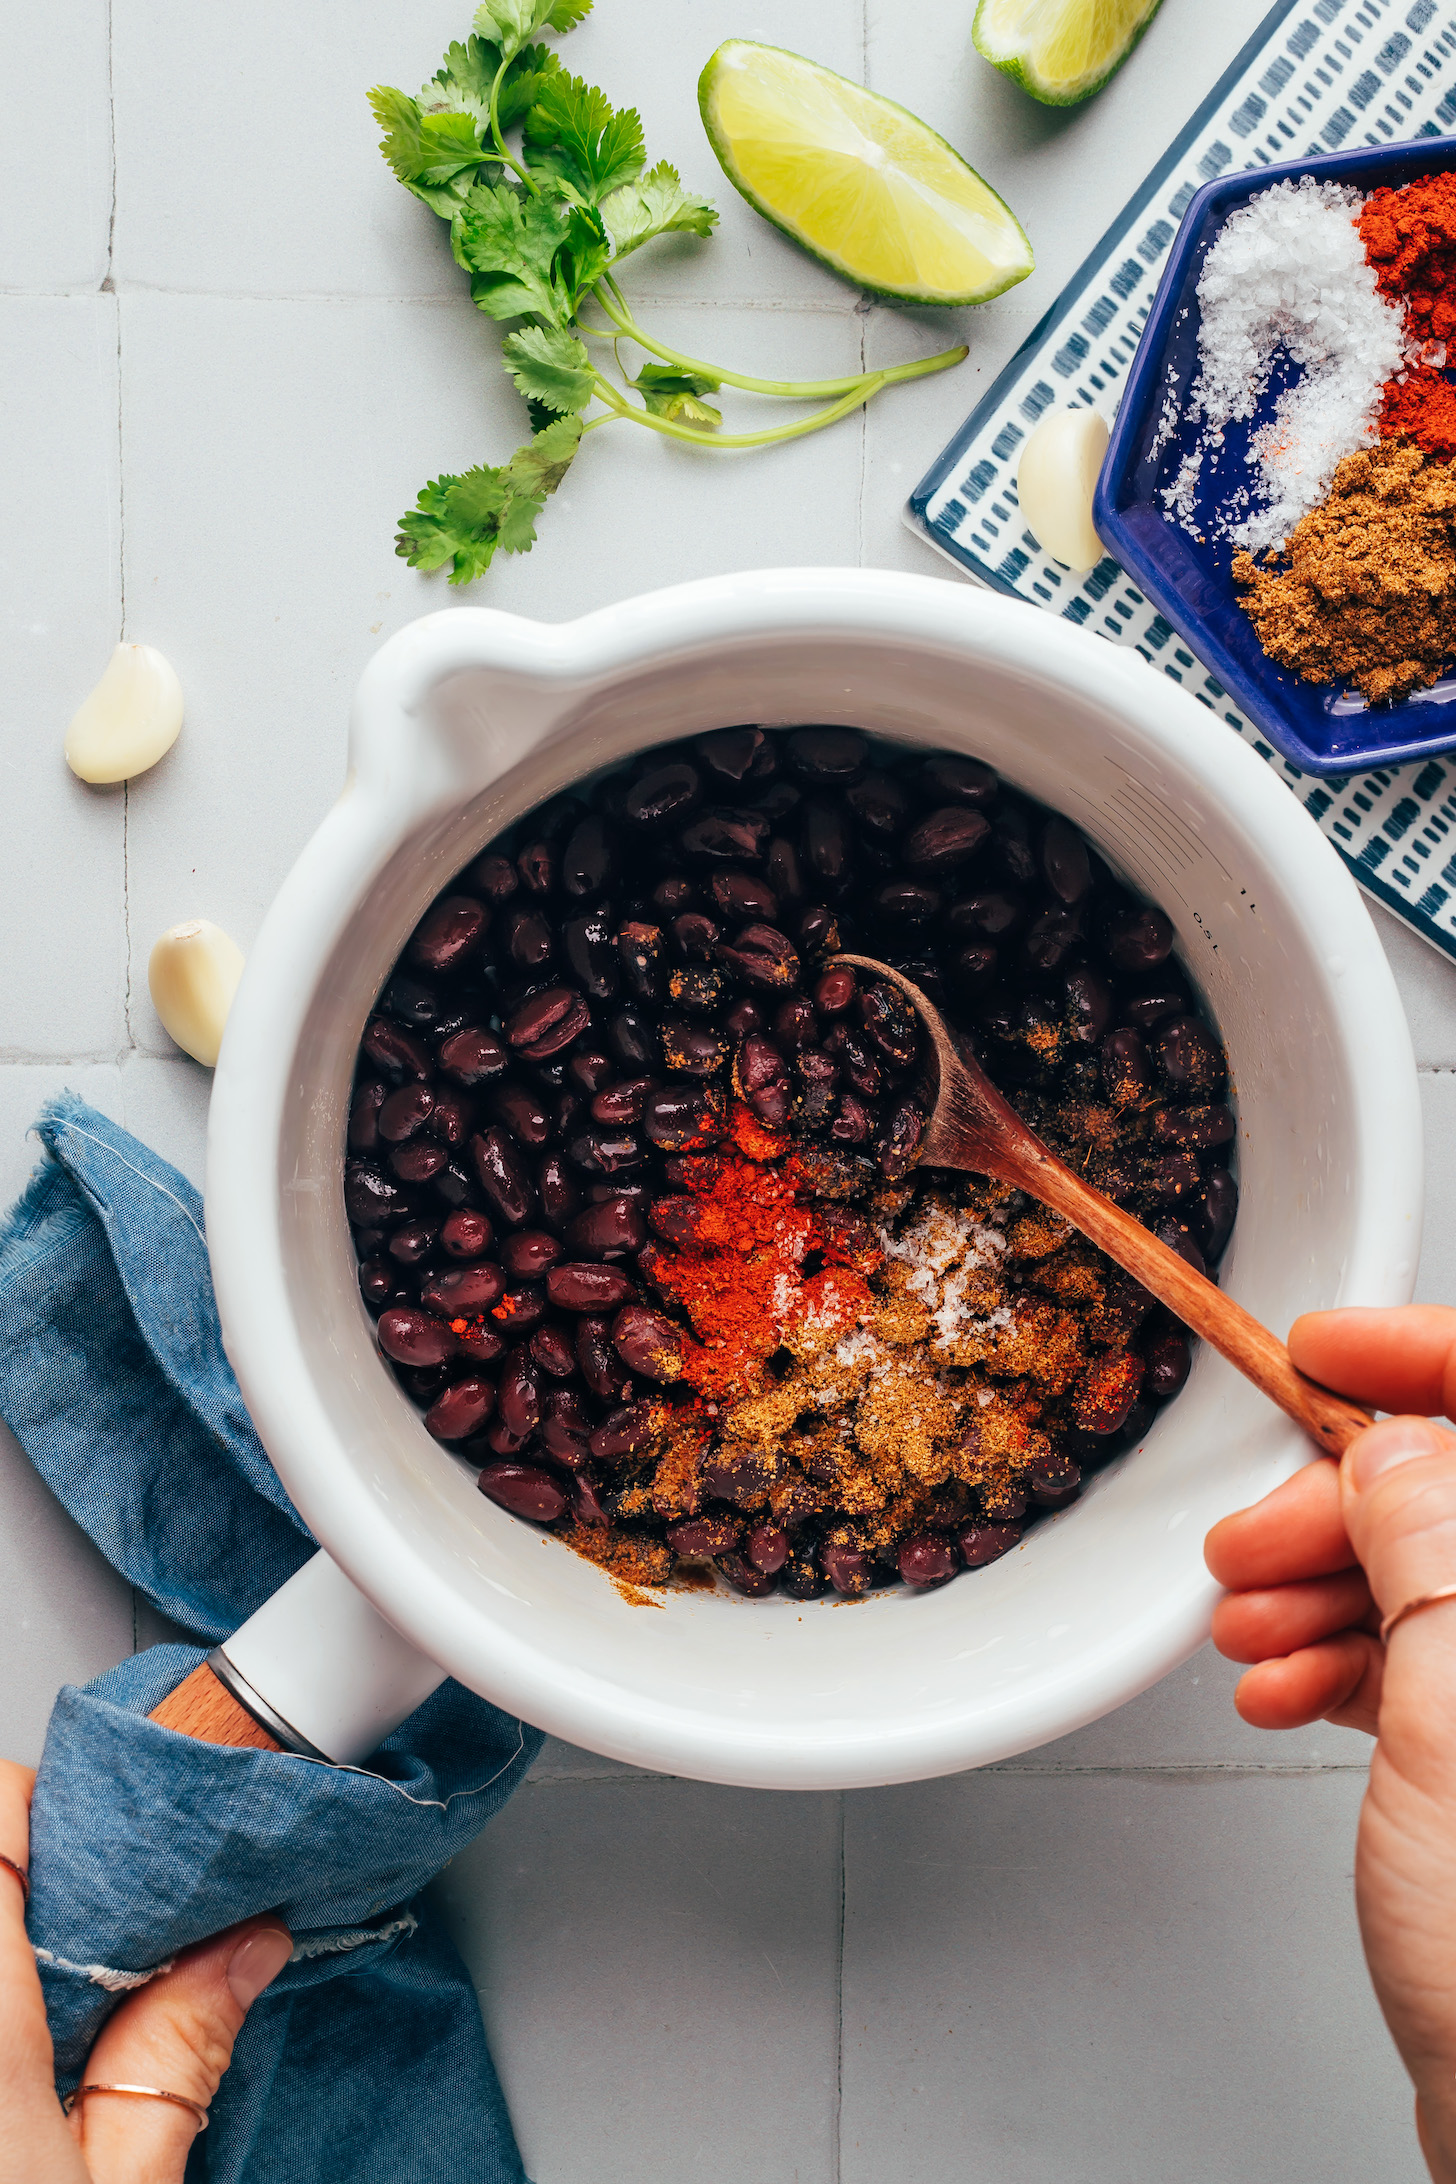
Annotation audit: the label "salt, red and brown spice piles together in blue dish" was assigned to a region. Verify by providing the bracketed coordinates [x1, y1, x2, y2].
[1161, 173, 1456, 703]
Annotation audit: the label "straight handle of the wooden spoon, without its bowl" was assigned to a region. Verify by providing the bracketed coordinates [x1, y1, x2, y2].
[1009, 1149, 1375, 1457]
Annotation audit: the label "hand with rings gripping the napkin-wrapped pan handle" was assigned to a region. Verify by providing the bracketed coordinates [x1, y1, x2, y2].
[0, 1760, 293, 2184]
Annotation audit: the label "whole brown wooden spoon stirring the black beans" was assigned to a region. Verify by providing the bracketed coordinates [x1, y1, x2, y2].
[834, 954, 1373, 1457]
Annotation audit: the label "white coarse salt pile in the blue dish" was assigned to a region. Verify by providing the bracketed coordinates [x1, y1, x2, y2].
[1161, 177, 1406, 553]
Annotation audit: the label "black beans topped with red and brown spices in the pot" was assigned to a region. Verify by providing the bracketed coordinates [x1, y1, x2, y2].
[345, 727, 1236, 1601]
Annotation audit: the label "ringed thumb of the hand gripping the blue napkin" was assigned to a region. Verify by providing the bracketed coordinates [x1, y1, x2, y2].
[72, 1918, 293, 2184]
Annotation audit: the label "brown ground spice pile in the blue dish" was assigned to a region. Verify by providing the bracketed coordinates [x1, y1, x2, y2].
[1233, 441, 1456, 703]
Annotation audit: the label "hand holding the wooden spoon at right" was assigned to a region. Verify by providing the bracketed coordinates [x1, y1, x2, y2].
[1205, 1306, 1456, 2184]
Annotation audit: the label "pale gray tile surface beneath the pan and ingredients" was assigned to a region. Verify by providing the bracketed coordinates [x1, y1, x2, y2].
[0, 0, 1456, 2184]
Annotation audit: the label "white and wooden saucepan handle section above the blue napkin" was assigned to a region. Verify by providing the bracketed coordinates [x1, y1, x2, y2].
[151, 1553, 445, 1767]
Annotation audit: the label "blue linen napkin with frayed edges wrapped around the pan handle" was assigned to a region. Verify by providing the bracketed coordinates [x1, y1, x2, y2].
[0, 1092, 541, 2184]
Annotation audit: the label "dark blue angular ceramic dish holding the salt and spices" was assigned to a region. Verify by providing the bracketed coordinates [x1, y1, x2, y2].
[1094, 138, 1456, 773]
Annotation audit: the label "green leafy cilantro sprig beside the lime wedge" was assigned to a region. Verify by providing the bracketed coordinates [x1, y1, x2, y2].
[369, 0, 967, 583]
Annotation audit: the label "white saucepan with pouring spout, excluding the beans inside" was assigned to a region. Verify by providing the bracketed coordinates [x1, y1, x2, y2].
[207, 570, 1421, 1789]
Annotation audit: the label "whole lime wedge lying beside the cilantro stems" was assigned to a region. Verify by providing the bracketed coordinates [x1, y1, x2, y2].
[699, 37, 1033, 304]
